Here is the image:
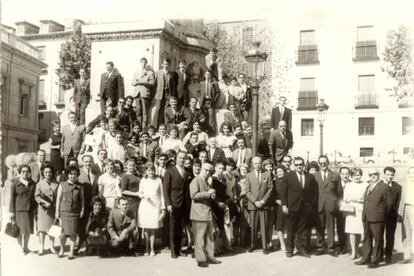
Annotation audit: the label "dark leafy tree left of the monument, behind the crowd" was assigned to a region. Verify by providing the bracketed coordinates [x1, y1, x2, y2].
[56, 23, 91, 89]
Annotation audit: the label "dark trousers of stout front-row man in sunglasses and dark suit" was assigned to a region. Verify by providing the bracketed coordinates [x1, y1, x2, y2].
[286, 206, 309, 253]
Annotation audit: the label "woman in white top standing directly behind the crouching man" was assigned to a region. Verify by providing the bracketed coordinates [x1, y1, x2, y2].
[98, 159, 121, 209]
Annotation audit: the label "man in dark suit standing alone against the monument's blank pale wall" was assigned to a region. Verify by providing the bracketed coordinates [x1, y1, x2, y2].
[99, 61, 124, 114]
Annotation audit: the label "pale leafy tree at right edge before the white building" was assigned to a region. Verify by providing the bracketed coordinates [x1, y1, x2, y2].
[382, 26, 414, 98]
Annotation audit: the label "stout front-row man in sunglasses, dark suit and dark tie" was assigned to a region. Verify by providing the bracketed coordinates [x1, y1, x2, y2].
[280, 157, 318, 258]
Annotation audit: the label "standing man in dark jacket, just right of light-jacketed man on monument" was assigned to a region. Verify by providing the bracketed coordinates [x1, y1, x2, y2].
[151, 58, 178, 128]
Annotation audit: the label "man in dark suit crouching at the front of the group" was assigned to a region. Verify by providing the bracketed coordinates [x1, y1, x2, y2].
[107, 197, 136, 254]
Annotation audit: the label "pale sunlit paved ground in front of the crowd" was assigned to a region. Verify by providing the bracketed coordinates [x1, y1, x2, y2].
[0, 233, 414, 276]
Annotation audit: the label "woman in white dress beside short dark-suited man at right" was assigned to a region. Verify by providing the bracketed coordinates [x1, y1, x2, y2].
[344, 168, 368, 260]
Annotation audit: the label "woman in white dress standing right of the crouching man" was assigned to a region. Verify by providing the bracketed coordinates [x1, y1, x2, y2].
[138, 162, 166, 256]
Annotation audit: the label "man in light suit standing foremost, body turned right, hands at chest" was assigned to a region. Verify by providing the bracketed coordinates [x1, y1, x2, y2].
[190, 163, 221, 267]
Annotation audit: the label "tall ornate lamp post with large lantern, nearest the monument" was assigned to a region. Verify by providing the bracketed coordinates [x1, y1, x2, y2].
[244, 41, 267, 156]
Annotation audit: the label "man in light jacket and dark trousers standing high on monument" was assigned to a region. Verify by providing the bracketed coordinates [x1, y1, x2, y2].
[132, 57, 155, 128]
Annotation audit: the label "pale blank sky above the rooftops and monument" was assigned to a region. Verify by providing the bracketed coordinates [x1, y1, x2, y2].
[1, 0, 414, 27]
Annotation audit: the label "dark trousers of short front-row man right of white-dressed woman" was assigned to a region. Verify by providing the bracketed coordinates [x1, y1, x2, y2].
[362, 221, 385, 264]
